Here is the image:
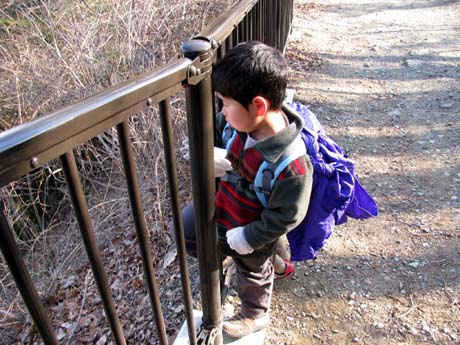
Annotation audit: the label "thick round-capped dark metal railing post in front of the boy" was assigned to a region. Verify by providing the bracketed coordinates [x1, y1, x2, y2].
[181, 39, 222, 345]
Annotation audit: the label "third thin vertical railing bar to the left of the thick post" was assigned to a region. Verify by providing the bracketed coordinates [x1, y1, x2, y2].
[61, 151, 126, 345]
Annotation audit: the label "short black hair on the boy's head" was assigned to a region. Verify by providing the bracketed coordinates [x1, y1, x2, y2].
[212, 41, 288, 109]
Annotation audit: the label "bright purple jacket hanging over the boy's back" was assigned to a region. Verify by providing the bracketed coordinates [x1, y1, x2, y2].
[287, 102, 378, 261]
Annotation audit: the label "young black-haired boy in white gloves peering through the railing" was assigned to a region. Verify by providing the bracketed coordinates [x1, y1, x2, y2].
[183, 42, 313, 338]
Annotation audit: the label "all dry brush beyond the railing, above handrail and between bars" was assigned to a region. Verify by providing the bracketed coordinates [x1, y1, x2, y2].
[0, 0, 236, 344]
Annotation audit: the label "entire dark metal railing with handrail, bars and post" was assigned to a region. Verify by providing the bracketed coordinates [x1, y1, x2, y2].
[0, 0, 293, 344]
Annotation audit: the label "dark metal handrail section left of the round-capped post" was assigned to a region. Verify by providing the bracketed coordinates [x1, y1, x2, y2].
[0, 58, 192, 187]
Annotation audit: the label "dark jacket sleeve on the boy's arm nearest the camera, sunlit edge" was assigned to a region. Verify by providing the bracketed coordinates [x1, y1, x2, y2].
[244, 158, 313, 250]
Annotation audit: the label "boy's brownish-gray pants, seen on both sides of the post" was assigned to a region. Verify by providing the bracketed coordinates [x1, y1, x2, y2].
[178, 204, 274, 318]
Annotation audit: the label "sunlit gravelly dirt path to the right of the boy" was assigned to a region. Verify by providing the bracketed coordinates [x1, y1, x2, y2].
[266, 0, 460, 345]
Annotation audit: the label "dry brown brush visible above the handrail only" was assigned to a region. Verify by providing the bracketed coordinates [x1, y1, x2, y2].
[0, 0, 234, 123]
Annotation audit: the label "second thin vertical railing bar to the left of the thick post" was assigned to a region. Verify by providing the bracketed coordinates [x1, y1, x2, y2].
[117, 120, 168, 344]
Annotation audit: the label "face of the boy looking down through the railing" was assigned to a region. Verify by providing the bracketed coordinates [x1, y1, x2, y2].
[217, 93, 260, 133]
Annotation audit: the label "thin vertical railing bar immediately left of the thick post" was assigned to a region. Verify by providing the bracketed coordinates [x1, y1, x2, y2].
[158, 99, 196, 345]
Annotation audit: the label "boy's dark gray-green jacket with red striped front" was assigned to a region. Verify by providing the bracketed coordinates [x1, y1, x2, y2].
[216, 108, 313, 256]
